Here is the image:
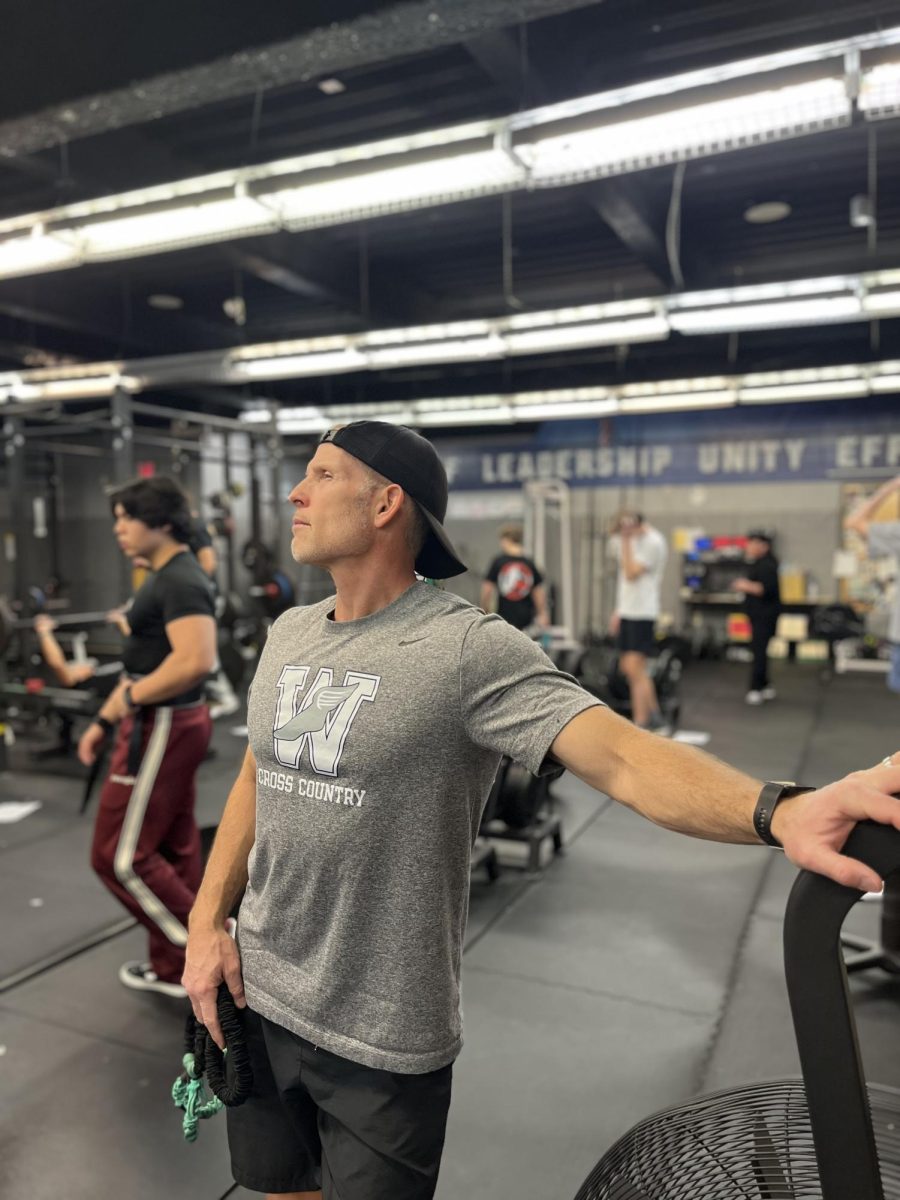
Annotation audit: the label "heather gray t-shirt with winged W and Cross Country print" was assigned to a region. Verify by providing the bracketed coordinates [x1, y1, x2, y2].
[238, 583, 598, 1074]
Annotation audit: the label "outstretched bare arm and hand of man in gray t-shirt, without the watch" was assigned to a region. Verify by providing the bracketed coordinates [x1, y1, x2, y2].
[551, 708, 900, 892]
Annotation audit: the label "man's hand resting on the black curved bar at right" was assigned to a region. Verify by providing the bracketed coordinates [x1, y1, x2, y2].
[772, 752, 900, 892]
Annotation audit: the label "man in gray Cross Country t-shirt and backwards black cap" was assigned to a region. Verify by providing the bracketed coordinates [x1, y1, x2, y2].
[184, 421, 900, 1200]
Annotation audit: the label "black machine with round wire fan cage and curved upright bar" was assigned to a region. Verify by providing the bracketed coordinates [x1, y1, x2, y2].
[576, 822, 900, 1200]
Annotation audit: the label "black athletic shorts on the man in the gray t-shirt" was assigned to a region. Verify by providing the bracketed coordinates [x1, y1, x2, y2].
[227, 1008, 452, 1200]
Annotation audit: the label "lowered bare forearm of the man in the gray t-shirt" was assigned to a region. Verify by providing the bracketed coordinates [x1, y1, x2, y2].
[188, 752, 257, 930]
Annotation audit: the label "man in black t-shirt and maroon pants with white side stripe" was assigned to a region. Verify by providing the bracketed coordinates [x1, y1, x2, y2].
[78, 475, 216, 996]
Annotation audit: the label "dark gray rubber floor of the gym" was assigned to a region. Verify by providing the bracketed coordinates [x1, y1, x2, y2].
[0, 664, 900, 1200]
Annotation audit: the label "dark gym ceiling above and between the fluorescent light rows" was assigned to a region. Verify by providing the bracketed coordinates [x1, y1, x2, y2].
[0, 0, 900, 432]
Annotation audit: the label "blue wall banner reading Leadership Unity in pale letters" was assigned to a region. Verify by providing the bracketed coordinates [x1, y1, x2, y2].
[438, 397, 900, 491]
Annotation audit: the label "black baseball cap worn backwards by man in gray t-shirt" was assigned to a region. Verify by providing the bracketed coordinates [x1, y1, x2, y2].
[319, 421, 468, 580]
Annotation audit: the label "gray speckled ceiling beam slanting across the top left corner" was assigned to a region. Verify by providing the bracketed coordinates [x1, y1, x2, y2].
[0, 0, 609, 157]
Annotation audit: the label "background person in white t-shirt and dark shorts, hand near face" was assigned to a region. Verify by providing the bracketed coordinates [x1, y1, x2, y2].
[610, 512, 668, 733]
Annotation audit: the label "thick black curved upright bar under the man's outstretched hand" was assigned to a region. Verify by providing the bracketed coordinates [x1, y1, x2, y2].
[784, 822, 900, 1200]
